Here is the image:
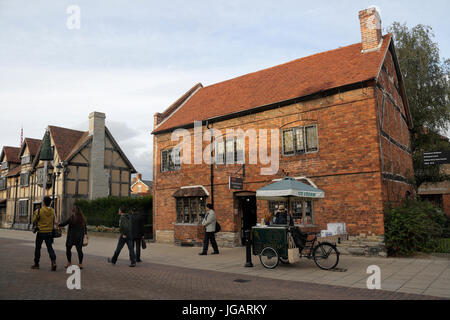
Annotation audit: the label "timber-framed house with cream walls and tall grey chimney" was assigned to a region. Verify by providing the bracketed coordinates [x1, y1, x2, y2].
[0, 112, 136, 229]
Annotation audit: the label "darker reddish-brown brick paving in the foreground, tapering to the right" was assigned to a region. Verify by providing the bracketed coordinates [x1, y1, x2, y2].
[0, 238, 442, 300]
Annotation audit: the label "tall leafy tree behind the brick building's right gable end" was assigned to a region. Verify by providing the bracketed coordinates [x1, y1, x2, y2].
[388, 22, 450, 187]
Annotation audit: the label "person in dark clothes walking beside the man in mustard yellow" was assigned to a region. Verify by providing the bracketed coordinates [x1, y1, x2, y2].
[59, 205, 87, 269]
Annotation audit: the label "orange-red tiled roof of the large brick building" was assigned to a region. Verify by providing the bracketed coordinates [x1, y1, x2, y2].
[153, 34, 391, 133]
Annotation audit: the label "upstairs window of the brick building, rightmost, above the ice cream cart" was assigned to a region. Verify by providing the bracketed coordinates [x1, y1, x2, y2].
[282, 125, 319, 156]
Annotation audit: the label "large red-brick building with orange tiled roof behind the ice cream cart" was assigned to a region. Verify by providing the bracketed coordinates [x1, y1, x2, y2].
[153, 8, 414, 246]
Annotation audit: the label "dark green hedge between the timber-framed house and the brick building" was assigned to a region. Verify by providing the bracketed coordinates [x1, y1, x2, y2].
[75, 196, 152, 228]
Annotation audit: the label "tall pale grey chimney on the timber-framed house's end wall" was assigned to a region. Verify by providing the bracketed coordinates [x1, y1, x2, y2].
[89, 112, 109, 199]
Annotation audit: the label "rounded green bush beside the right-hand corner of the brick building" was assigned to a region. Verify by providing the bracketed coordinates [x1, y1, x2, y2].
[384, 200, 446, 256]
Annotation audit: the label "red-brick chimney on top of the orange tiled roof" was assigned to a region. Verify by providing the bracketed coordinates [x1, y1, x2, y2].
[359, 7, 383, 53]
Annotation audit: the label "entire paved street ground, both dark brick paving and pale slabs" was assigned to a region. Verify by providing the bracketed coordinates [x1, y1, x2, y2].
[0, 229, 450, 299]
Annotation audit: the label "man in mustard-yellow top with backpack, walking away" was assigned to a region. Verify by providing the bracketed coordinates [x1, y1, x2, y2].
[31, 196, 56, 271]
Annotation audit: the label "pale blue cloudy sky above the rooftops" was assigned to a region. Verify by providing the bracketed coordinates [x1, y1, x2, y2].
[0, 0, 450, 180]
